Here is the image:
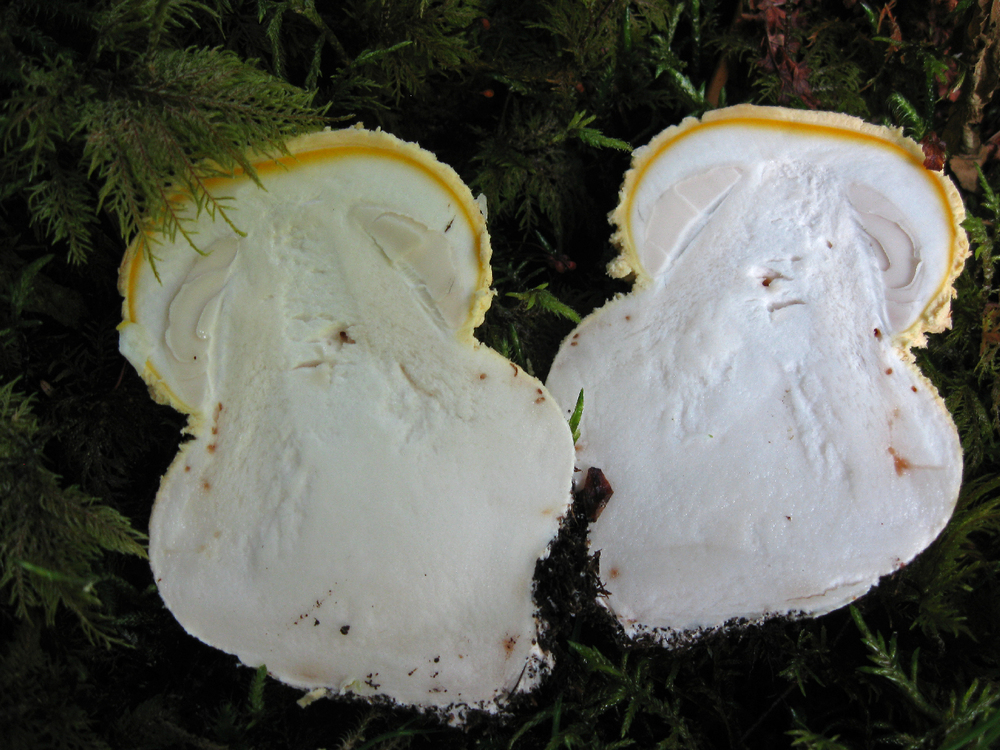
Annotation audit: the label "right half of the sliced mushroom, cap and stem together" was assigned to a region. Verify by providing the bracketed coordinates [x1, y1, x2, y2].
[548, 106, 968, 643]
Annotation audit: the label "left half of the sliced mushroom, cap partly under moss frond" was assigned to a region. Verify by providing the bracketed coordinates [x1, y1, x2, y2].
[120, 128, 573, 720]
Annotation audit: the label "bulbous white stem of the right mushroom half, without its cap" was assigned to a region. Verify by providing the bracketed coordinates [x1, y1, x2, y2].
[548, 154, 962, 640]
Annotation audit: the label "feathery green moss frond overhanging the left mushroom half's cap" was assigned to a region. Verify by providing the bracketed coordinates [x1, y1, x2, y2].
[0, 0, 323, 262]
